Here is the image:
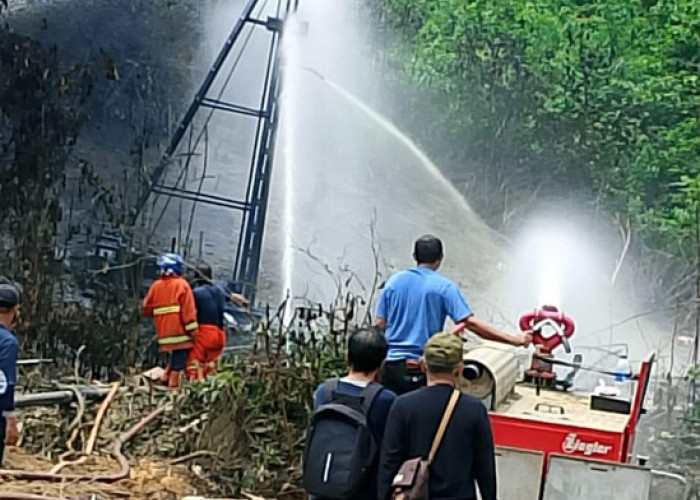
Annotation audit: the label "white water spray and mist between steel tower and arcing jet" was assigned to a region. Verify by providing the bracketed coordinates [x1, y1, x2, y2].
[266, 0, 504, 311]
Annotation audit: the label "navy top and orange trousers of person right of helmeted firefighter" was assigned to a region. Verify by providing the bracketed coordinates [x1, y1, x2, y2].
[188, 284, 226, 378]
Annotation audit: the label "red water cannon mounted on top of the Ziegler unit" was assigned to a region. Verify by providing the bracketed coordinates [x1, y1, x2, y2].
[519, 306, 576, 385]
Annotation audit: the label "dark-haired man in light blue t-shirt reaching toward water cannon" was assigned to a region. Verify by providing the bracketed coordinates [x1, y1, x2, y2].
[377, 235, 532, 395]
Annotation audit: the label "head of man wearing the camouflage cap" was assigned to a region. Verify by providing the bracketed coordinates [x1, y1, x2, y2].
[423, 332, 464, 384]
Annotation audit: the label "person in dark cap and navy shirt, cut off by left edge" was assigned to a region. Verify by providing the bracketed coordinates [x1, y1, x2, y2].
[0, 283, 19, 463]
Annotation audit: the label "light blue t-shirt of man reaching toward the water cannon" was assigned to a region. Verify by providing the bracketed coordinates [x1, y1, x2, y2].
[377, 266, 472, 361]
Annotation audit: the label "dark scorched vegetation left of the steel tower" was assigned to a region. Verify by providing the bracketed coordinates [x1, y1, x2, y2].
[0, 0, 208, 370]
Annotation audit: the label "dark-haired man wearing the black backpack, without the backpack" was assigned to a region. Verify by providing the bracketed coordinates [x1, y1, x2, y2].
[314, 328, 396, 500]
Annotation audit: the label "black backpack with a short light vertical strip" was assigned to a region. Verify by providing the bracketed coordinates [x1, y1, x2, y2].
[303, 378, 383, 500]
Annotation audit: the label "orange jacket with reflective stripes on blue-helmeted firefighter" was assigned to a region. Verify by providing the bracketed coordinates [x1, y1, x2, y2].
[142, 276, 198, 384]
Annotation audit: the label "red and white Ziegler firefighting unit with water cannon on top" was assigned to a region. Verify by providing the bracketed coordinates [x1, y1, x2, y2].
[460, 307, 676, 500]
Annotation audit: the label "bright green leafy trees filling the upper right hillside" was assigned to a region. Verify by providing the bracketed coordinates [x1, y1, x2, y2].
[379, 0, 700, 308]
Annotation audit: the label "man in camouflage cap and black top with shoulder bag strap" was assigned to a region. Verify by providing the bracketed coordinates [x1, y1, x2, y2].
[377, 332, 497, 500]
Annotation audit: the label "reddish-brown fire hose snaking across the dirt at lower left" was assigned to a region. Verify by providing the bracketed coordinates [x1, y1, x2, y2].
[0, 407, 165, 484]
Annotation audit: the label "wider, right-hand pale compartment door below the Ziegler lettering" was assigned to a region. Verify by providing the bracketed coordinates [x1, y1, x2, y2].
[544, 455, 651, 500]
